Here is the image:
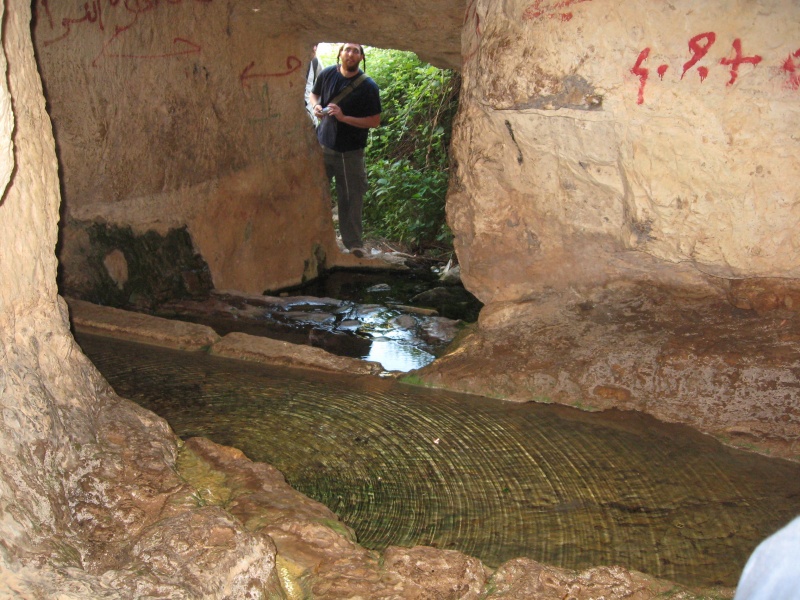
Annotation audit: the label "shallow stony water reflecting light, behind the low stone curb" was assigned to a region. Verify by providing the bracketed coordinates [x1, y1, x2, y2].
[152, 270, 481, 371]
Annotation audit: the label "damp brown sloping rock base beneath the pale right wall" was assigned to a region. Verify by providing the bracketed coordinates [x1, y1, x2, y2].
[417, 284, 800, 460]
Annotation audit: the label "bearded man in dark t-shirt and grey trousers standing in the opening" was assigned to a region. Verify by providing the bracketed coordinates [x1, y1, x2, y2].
[310, 42, 381, 258]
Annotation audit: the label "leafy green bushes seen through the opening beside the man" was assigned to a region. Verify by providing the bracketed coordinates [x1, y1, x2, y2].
[364, 48, 461, 250]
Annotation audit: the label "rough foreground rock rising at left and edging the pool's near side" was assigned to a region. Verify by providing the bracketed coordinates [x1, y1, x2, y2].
[0, 5, 731, 600]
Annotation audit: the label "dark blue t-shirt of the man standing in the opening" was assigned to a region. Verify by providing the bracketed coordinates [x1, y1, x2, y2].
[311, 65, 381, 152]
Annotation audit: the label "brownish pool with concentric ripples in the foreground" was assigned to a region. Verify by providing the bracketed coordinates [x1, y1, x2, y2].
[79, 336, 800, 586]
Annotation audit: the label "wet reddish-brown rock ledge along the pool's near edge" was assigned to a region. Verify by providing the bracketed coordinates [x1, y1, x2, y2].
[179, 438, 733, 600]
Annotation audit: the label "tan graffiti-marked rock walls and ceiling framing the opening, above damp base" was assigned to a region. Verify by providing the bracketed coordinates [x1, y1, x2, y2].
[28, 0, 800, 304]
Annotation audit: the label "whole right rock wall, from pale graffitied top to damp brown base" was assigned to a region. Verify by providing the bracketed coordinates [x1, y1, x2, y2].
[420, 0, 800, 460]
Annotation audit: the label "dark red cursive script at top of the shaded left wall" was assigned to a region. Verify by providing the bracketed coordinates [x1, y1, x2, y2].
[36, 0, 212, 66]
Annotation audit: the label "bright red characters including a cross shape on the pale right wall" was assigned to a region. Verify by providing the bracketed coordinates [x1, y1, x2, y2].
[630, 31, 776, 104]
